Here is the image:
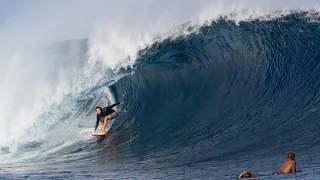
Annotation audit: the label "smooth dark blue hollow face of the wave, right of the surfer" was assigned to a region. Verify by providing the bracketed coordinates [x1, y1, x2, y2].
[113, 12, 320, 176]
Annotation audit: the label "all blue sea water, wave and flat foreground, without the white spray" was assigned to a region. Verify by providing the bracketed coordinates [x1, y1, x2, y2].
[0, 11, 320, 179]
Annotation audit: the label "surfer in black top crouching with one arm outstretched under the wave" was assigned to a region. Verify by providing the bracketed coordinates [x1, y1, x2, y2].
[93, 100, 124, 133]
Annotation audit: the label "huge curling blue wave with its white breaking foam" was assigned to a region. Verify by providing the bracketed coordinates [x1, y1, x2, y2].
[1, 7, 320, 179]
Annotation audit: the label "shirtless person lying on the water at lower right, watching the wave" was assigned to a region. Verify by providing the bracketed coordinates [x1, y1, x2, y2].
[238, 152, 297, 179]
